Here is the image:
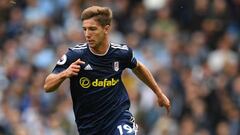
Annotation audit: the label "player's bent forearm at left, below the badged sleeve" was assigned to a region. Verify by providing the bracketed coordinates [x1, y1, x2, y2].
[44, 71, 67, 92]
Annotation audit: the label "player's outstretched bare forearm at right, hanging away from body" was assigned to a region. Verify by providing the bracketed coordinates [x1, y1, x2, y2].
[133, 62, 163, 97]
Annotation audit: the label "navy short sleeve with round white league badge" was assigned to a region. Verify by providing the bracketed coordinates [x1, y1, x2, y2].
[52, 48, 79, 73]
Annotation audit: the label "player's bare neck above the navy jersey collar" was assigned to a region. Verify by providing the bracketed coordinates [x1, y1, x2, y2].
[89, 39, 109, 55]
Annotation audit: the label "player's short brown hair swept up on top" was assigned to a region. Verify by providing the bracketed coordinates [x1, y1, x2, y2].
[81, 6, 112, 26]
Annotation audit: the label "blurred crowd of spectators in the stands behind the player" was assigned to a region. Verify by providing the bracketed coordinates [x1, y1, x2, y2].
[0, 0, 240, 135]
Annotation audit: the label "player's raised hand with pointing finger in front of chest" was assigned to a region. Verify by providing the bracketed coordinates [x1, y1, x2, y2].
[65, 59, 85, 78]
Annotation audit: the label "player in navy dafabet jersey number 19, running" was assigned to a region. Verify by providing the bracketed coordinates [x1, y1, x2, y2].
[44, 6, 170, 135]
